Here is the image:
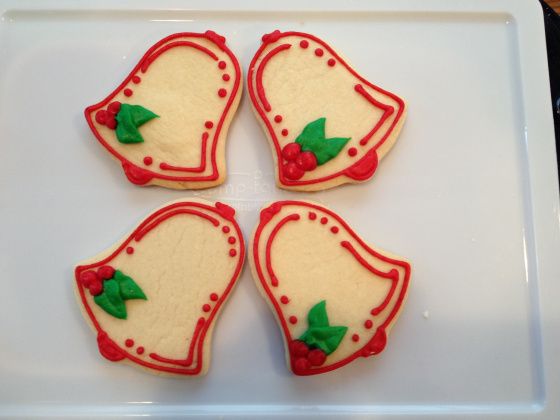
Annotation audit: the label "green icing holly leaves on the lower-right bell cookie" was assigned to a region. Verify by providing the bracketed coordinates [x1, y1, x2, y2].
[299, 300, 348, 355]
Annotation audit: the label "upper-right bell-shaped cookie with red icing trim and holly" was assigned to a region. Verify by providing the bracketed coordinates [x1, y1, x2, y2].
[247, 31, 406, 191]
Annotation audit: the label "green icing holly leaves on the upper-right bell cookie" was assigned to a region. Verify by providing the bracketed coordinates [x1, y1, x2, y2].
[295, 118, 350, 165]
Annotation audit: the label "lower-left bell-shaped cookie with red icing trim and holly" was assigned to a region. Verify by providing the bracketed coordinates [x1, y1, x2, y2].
[74, 199, 245, 376]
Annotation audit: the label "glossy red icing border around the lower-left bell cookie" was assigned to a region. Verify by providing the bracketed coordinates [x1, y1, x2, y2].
[74, 201, 245, 375]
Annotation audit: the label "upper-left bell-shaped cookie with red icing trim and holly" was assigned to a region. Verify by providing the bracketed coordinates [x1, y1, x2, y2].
[85, 31, 242, 189]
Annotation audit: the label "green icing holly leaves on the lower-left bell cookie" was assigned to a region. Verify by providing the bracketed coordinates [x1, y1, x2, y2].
[93, 270, 148, 319]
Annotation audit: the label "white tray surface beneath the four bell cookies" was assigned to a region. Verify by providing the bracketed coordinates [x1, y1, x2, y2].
[0, 0, 560, 419]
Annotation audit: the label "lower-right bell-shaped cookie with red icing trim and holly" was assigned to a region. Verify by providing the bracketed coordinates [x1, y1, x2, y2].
[249, 201, 410, 375]
